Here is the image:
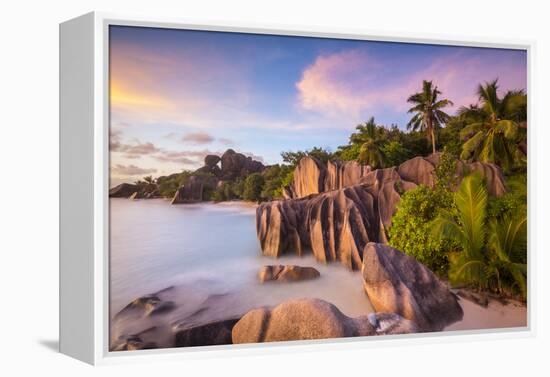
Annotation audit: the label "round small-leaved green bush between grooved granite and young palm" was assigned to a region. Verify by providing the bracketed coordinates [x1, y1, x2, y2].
[389, 185, 453, 275]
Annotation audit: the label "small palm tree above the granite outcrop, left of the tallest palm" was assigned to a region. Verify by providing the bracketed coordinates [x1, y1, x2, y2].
[350, 117, 385, 169]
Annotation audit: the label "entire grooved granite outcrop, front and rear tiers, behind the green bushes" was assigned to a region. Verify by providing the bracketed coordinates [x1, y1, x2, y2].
[256, 154, 506, 269]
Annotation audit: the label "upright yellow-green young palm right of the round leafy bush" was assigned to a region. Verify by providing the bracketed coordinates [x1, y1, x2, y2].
[432, 174, 488, 288]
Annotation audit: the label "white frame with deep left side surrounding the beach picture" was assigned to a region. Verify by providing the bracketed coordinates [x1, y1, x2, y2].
[60, 12, 537, 364]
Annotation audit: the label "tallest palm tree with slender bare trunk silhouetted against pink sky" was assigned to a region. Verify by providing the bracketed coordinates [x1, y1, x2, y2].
[407, 80, 453, 153]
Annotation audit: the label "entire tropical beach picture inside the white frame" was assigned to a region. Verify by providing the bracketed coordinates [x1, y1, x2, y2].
[109, 26, 529, 351]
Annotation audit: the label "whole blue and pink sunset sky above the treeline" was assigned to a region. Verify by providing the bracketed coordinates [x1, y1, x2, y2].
[109, 26, 527, 186]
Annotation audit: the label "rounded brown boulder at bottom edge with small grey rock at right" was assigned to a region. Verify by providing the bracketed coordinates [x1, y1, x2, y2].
[232, 299, 417, 344]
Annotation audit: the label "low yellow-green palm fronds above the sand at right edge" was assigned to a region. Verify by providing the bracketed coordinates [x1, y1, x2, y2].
[432, 173, 527, 298]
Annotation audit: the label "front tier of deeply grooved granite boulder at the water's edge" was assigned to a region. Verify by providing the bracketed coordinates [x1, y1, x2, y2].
[256, 169, 406, 269]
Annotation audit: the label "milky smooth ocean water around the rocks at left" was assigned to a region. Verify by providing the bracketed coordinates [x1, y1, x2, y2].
[110, 198, 372, 326]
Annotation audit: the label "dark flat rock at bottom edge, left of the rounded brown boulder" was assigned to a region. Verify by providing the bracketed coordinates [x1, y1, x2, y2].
[174, 318, 239, 347]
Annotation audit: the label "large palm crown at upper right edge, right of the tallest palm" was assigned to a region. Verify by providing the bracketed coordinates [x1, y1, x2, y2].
[458, 80, 527, 169]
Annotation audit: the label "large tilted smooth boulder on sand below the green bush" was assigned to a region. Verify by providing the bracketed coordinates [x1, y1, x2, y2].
[362, 242, 463, 331]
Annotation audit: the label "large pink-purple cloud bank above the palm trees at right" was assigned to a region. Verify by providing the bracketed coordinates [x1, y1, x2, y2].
[296, 48, 527, 118]
